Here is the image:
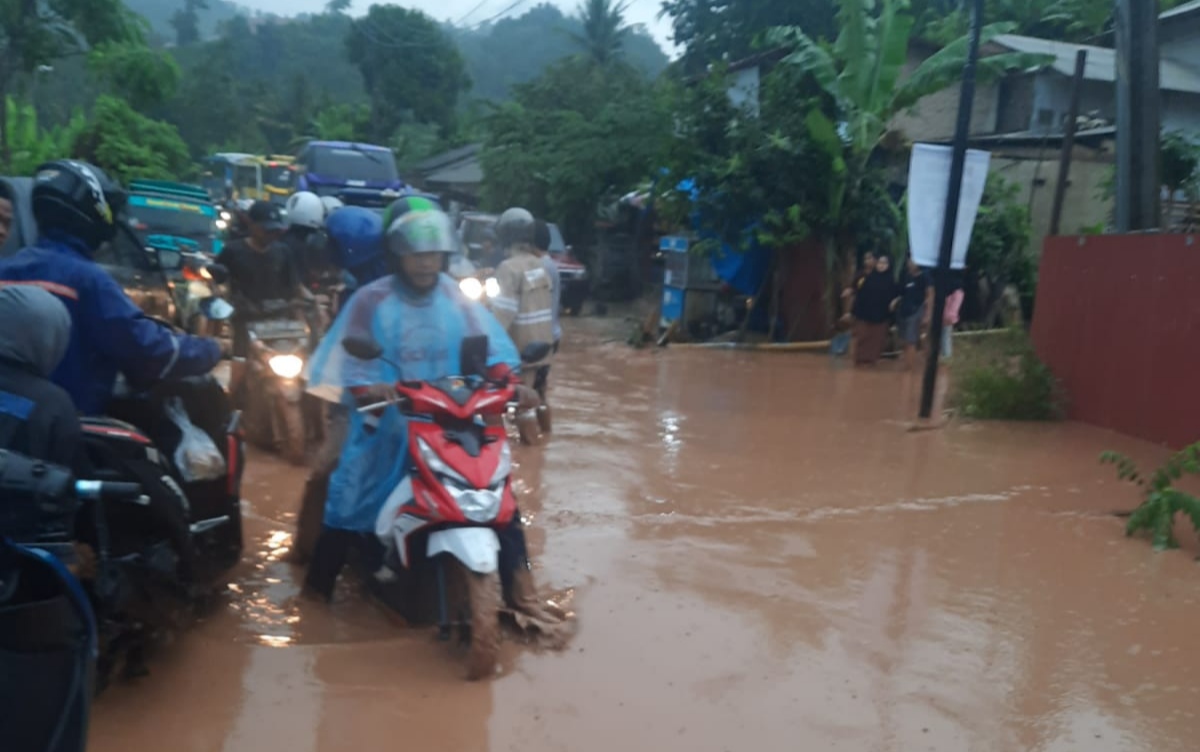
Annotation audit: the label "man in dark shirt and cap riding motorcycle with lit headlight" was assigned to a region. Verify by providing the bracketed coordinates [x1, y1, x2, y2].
[221, 201, 306, 393]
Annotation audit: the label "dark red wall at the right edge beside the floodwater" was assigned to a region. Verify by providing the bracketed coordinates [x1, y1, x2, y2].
[1033, 235, 1200, 447]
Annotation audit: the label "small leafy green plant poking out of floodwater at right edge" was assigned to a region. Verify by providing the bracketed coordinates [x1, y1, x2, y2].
[1100, 441, 1200, 551]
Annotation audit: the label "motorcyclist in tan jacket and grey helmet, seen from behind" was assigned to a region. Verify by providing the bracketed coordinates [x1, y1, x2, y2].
[492, 207, 554, 444]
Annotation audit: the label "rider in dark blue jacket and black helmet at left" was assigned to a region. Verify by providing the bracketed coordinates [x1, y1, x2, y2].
[0, 160, 222, 415]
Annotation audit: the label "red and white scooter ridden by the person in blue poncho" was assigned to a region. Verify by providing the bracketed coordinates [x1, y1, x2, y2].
[342, 336, 551, 679]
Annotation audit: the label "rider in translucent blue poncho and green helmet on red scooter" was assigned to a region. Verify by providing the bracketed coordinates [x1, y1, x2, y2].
[305, 209, 556, 613]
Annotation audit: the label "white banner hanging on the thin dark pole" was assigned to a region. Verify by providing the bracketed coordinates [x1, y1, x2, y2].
[908, 144, 991, 269]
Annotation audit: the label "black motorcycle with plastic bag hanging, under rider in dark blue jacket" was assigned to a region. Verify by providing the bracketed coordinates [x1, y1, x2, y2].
[82, 299, 245, 680]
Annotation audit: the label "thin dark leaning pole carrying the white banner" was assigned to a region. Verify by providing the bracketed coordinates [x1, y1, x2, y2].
[920, 0, 983, 417]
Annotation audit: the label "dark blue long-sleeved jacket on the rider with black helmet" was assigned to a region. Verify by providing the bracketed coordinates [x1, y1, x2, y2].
[0, 233, 221, 415]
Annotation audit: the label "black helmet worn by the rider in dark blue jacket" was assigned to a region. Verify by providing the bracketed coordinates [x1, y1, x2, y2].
[34, 160, 127, 251]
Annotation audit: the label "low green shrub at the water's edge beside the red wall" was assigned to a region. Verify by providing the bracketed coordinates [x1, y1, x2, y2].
[953, 330, 1066, 421]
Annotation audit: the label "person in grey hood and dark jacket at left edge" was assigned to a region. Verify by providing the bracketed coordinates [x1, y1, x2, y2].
[0, 284, 85, 474]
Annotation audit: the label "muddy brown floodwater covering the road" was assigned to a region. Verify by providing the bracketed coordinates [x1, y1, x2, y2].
[91, 319, 1200, 752]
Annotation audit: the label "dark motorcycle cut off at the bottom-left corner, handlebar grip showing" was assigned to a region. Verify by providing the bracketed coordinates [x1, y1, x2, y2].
[0, 451, 142, 752]
